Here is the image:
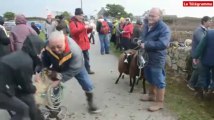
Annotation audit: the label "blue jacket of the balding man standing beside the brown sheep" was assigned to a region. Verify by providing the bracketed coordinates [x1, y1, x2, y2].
[142, 20, 171, 68]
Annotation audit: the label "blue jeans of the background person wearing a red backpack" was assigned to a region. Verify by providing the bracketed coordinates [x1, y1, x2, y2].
[99, 34, 110, 54]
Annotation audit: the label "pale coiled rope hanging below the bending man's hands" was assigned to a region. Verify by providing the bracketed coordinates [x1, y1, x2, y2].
[35, 69, 68, 120]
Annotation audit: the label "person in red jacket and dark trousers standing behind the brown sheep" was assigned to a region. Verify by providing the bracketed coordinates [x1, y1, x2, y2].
[121, 18, 134, 50]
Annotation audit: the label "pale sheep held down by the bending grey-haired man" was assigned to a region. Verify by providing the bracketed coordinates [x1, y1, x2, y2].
[32, 69, 67, 120]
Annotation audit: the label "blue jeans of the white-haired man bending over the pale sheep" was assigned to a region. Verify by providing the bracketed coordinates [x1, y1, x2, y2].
[74, 67, 93, 92]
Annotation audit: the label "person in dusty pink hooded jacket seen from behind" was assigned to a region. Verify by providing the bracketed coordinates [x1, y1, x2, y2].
[10, 15, 37, 51]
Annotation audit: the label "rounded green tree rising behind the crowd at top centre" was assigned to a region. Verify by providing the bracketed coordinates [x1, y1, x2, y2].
[106, 4, 133, 18]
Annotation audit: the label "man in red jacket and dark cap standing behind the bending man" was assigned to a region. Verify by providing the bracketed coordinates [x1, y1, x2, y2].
[69, 8, 94, 74]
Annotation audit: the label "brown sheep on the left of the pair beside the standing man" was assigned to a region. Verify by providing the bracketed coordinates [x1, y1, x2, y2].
[115, 49, 136, 86]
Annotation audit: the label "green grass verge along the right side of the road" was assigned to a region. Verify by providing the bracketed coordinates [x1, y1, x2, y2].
[111, 44, 214, 120]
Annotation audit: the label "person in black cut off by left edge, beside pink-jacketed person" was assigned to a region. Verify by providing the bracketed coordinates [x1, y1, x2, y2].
[0, 16, 10, 57]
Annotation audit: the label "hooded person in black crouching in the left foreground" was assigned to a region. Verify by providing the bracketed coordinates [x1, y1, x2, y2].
[0, 35, 44, 120]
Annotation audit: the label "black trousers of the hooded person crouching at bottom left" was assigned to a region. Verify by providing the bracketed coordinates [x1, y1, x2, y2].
[0, 93, 43, 120]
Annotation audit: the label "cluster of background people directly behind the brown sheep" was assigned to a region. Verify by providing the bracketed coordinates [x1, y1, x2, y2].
[110, 17, 143, 51]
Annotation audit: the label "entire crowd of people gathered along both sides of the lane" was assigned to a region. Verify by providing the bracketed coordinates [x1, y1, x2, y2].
[0, 5, 214, 120]
